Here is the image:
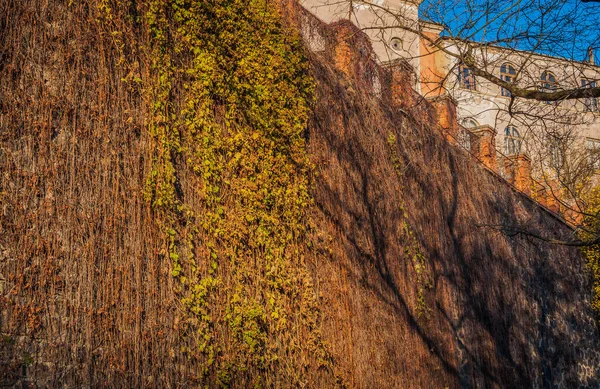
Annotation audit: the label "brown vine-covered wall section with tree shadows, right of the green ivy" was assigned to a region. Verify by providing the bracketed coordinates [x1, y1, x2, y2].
[294, 2, 600, 388]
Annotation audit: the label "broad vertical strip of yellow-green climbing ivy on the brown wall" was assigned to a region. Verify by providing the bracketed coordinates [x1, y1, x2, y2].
[139, 0, 342, 387]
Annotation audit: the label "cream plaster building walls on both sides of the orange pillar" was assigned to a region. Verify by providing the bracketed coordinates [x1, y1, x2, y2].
[301, 0, 600, 177]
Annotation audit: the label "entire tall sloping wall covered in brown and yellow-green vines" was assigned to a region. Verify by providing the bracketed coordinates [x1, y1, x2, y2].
[0, 0, 600, 388]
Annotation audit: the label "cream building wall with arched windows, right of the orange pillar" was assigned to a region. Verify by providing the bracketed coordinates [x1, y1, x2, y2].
[446, 41, 600, 174]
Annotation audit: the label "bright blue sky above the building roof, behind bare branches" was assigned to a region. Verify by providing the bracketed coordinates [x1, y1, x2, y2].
[420, 0, 600, 63]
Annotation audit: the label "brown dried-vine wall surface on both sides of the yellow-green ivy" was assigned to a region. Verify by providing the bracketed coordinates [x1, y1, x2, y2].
[0, 0, 600, 388]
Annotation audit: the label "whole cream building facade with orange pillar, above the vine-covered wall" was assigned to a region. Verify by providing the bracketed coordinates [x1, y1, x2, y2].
[301, 0, 600, 210]
